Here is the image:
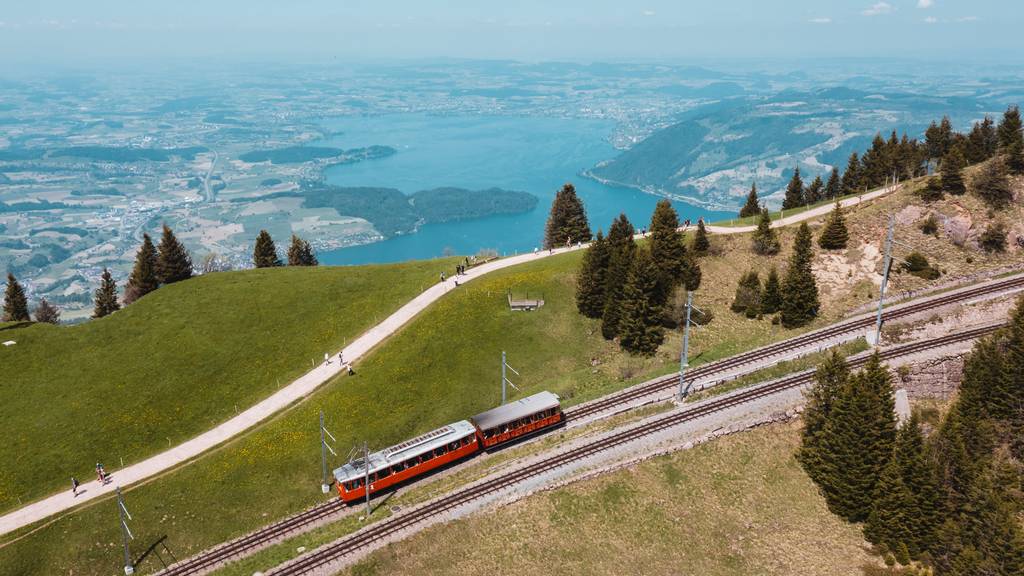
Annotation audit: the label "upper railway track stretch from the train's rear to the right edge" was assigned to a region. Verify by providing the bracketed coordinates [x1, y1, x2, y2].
[565, 275, 1024, 421]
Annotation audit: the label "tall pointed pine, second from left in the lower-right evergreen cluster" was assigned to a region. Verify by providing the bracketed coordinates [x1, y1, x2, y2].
[817, 352, 896, 522]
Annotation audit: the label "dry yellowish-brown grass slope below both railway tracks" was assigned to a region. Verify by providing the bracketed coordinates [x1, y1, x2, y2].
[343, 424, 873, 576]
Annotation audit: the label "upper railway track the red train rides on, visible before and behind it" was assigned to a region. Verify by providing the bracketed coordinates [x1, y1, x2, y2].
[160, 275, 1024, 576]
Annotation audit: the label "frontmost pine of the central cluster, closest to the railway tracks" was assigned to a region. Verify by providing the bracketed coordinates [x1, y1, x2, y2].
[618, 250, 665, 357]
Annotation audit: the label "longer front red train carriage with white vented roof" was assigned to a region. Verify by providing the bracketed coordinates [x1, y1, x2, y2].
[334, 420, 480, 502]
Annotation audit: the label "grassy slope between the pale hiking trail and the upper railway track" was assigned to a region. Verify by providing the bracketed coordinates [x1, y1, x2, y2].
[0, 171, 1020, 574]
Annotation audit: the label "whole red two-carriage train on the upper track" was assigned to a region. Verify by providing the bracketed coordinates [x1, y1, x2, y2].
[334, 392, 564, 502]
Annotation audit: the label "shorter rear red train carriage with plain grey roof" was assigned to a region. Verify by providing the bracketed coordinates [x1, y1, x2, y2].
[470, 392, 564, 448]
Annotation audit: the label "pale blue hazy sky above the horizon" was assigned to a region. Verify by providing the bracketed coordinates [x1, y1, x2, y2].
[0, 0, 1024, 67]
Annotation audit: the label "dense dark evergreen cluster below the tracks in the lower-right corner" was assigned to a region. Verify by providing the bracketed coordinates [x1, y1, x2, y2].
[798, 298, 1024, 576]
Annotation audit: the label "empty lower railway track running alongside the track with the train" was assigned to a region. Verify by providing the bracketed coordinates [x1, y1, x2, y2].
[267, 325, 1001, 576]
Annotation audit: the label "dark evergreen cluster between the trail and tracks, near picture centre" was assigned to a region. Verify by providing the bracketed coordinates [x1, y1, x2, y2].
[577, 200, 707, 356]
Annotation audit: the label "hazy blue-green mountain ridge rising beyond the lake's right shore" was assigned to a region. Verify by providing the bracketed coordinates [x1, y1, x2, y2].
[585, 83, 985, 209]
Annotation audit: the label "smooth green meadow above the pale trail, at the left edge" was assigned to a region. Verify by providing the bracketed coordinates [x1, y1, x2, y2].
[0, 261, 456, 510]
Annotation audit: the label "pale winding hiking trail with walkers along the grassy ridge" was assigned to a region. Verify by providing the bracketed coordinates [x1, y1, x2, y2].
[0, 184, 899, 534]
